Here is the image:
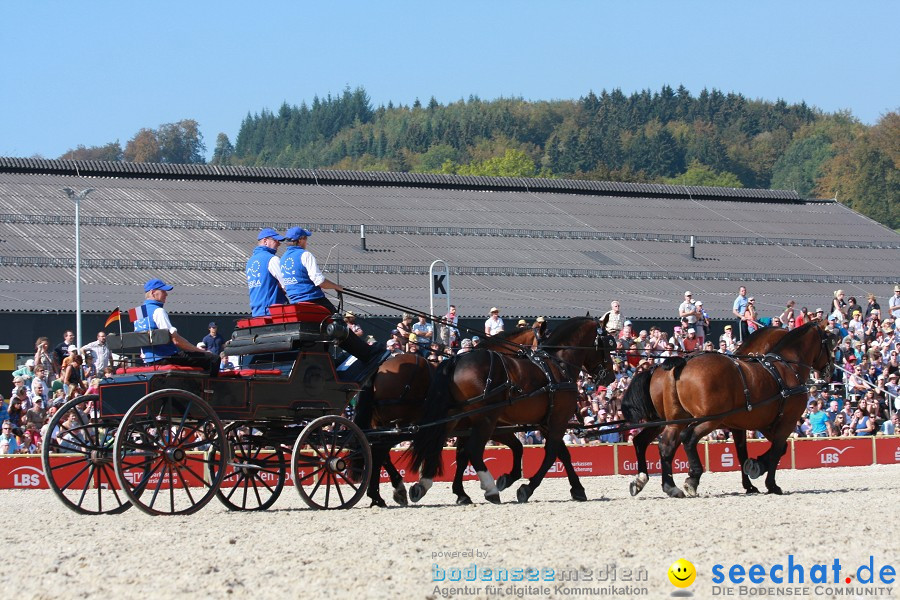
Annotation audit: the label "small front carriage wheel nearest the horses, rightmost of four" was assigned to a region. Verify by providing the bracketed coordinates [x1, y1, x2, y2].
[291, 416, 372, 509]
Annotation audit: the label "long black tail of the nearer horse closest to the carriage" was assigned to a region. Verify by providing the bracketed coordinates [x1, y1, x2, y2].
[407, 356, 457, 475]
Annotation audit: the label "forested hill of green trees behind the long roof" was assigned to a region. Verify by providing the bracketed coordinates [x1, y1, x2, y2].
[62, 86, 900, 229]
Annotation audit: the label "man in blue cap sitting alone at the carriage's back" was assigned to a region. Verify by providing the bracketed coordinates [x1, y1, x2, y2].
[134, 279, 219, 375]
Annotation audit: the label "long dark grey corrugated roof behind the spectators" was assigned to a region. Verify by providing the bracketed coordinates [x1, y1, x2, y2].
[0, 158, 900, 317]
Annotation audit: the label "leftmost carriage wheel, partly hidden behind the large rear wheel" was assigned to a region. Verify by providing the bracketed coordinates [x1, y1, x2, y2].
[41, 394, 138, 515]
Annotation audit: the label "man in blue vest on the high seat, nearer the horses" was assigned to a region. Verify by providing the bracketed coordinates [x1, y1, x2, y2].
[281, 227, 390, 372]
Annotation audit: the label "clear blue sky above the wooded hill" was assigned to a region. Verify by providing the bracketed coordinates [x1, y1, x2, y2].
[0, 0, 900, 158]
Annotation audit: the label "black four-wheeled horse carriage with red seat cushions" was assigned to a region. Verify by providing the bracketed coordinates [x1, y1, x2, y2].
[43, 304, 372, 514]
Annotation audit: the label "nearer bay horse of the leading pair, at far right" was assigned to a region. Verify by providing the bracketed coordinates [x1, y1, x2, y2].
[622, 322, 837, 497]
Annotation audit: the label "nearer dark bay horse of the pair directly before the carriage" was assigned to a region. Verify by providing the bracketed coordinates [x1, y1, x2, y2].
[410, 317, 614, 503]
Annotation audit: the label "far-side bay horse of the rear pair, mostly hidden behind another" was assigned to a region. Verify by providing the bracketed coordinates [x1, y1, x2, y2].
[354, 328, 544, 507]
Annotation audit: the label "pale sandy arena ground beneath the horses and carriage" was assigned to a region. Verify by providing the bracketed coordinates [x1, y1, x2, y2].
[0, 465, 900, 600]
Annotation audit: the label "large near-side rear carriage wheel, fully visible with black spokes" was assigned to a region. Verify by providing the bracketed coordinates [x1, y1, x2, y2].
[113, 389, 226, 515]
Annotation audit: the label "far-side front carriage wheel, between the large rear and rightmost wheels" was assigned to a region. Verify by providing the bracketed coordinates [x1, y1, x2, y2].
[209, 426, 287, 510]
